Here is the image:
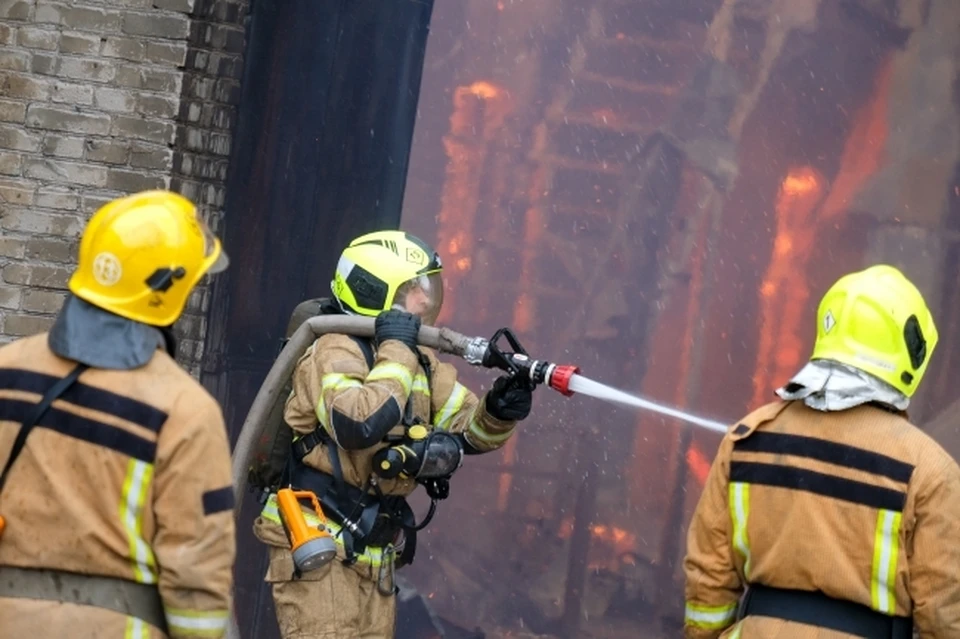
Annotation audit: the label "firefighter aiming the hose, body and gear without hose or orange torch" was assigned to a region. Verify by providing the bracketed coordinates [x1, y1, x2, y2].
[254, 231, 532, 639]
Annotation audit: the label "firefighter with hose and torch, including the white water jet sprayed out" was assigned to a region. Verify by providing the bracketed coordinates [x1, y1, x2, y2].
[234, 231, 722, 637]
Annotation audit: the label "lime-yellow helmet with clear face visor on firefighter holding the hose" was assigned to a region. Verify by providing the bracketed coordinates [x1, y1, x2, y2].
[330, 231, 443, 324]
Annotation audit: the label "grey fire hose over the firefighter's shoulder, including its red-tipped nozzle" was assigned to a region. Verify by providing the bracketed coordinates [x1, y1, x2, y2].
[226, 315, 580, 639]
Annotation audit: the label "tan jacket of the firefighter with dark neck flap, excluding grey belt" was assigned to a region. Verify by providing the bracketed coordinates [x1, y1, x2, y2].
[0, 334, 236, 639]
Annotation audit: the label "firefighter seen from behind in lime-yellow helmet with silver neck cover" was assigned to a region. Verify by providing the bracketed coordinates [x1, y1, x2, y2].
[684, 265, 960, 639]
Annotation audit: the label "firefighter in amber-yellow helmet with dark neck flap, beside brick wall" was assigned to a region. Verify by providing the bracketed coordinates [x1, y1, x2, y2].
[0, 191, 235, 639]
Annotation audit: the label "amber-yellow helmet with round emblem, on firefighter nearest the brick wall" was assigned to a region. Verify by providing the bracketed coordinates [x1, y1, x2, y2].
[69, 191, 227, 326]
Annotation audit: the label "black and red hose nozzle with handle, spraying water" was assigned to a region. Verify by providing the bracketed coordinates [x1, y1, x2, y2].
[463, 328, 580, 397]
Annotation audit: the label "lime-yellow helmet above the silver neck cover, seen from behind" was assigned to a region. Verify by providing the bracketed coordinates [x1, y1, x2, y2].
[811, 265, 938, 397]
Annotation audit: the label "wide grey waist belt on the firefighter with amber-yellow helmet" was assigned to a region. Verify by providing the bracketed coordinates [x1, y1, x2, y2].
[0, 566, 169, 634]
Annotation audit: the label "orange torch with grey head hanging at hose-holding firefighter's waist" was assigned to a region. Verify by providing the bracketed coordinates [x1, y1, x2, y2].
[277, 488, 337, 572]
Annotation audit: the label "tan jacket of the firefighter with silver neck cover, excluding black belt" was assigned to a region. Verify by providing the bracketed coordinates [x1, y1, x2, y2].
[684, 401, 960, 639]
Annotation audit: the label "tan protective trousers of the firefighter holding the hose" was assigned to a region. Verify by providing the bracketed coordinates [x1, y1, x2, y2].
[267, 547, 397, 639]
